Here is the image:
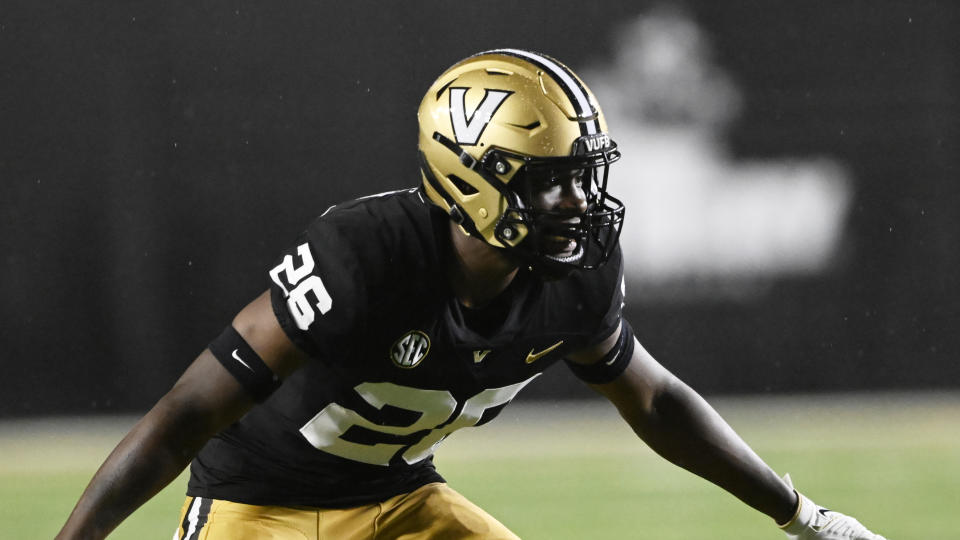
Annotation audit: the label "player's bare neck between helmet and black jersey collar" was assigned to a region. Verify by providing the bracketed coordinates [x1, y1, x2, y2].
[448, 223, 517, 307]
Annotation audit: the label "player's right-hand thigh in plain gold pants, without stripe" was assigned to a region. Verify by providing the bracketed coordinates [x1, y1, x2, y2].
[376, 483, 519, 540]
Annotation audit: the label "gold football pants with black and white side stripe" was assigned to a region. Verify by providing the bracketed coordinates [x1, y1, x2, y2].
[174, 483, 519, 540]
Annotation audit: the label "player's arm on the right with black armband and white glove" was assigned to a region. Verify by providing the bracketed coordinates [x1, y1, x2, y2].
[567, 323, 882, 540]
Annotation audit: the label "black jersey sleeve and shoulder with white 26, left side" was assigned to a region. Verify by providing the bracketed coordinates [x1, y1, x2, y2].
[269, 190, 436, 358]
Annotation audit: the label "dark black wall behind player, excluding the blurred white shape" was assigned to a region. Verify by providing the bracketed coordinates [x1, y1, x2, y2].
[0, 0, 960, 416]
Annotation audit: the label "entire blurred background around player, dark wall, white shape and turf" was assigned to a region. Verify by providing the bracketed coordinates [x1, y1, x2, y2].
[0, 0, 960, 538]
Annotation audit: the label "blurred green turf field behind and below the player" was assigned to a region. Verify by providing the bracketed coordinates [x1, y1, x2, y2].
[0, 394, 960, 540]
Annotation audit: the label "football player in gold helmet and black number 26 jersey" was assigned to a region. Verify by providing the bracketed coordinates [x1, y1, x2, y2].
[59, 49, 881, 540]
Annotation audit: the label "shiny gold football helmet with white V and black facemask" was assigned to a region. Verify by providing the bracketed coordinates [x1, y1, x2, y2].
[417, 49, 624, 274]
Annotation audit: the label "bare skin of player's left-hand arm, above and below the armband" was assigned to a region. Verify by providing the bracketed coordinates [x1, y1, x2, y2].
[57, 293, 304, 539]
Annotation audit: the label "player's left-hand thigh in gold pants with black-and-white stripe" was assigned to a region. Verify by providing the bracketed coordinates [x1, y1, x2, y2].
[174, 497, 317, 540]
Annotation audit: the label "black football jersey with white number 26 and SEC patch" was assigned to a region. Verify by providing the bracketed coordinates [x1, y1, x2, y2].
[188, 189, 623, 507]
